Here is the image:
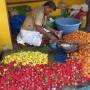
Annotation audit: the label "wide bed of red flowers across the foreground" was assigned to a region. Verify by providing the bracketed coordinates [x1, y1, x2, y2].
[0, 58, 87, 90]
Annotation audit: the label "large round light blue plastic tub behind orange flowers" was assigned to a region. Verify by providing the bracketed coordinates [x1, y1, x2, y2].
[55, 18, 81, 35]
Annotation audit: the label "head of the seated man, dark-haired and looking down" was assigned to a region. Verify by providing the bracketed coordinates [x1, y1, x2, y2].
[44, 1, 56, 14]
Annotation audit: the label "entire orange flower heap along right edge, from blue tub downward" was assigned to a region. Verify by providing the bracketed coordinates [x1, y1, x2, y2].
[64, 31, 90, 79]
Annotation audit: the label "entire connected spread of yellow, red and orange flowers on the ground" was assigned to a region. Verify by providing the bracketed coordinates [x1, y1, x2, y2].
[0, 31, 90, 90]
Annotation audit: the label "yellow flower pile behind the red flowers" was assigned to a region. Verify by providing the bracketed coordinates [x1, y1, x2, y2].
[3, 51, 48, 65]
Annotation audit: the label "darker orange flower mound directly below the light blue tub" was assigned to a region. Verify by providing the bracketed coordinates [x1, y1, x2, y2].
[63, 30, 90, 45]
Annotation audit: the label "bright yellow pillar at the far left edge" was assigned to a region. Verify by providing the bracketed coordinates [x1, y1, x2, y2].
[0, 0, 12, 50]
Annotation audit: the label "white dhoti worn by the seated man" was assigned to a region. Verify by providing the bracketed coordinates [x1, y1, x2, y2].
[17, 29, 43, 46]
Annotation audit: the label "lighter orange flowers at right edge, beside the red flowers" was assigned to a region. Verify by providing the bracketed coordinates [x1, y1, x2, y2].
[72, 44, 90, 79]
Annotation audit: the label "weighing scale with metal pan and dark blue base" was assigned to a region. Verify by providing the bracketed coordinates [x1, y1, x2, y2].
[49, 42, 80, 63]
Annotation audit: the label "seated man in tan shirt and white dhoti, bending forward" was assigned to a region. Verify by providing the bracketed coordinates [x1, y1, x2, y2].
[17, 1, 61, 46]
